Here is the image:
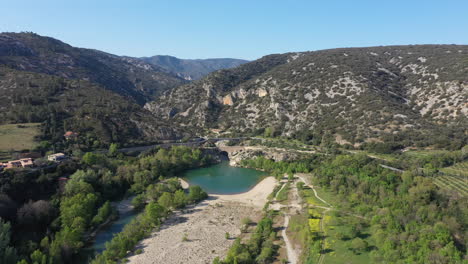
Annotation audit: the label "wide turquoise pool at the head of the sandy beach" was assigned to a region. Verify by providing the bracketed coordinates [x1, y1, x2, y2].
[183, 162, 266, 194]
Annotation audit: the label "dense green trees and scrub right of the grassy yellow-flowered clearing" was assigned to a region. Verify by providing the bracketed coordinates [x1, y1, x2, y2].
[313, 155, 468, 263]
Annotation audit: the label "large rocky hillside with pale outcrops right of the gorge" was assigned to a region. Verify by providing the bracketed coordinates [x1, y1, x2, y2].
[146, 45, 468, 146]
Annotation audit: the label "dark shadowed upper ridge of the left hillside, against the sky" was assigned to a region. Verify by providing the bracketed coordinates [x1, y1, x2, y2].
[0, 33, 184, 103]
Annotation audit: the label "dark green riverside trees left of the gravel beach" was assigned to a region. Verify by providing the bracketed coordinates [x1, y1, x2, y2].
[0, 147, 211, 264]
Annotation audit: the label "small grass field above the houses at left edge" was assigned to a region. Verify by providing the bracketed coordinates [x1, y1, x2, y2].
[0, 123, 40, 160]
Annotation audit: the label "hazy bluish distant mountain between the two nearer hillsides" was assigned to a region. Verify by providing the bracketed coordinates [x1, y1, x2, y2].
[141, 55, 248, 80]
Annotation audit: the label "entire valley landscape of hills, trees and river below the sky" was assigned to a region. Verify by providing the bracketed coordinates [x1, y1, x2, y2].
[0, 32, 468, 264]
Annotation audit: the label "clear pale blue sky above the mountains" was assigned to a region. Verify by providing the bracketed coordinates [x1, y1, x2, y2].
[0, 0, 468, 59]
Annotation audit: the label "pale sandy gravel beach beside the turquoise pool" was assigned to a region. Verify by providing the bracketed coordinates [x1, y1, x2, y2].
[128, 177, 277, 264]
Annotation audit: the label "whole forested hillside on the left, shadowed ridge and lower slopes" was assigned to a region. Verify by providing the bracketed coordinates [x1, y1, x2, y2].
[0, 33, 184, 147]
